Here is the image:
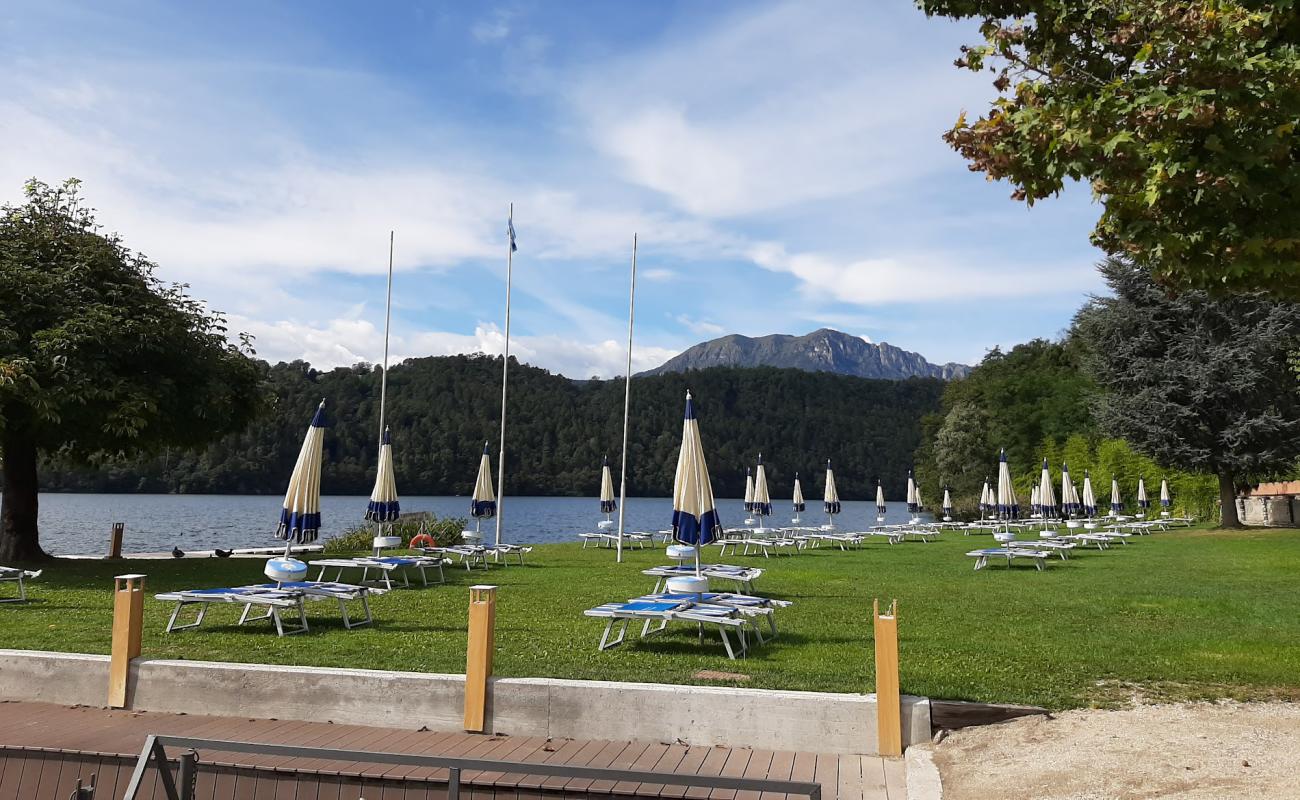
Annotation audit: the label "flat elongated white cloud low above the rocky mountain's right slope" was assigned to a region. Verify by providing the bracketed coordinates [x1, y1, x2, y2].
[750, 242, 1096, 306]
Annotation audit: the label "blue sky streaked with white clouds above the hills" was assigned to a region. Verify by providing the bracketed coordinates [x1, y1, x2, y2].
[0, 0, 1100, 377]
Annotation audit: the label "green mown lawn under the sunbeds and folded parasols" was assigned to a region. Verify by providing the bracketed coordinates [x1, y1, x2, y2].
[0, 531, 1300, 709]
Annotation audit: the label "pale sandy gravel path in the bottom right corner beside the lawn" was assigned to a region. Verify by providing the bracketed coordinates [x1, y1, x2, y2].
[935, 702, 1300, 800]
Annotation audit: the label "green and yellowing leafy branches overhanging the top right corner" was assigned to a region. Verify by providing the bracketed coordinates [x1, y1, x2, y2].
[919, 0, 1300, 297]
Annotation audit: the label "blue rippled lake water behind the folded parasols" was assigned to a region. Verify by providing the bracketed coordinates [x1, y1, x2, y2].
[32, 494, 935, 555]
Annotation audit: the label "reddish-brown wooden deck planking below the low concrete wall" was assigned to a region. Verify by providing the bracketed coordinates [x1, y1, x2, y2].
[0, 702, 906, 800]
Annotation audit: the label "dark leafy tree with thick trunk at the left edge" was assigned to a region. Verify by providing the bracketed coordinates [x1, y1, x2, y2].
[0, 181, 261, 562]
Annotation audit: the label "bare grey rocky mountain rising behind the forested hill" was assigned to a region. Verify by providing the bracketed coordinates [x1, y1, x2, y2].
[642, 328, 970, 380]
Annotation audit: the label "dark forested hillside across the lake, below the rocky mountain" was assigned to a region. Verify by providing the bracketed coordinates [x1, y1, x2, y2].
[42, 355, 944, 500]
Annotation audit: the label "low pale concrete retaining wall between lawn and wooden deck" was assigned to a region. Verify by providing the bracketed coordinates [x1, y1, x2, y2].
[0, 650, 930, 754]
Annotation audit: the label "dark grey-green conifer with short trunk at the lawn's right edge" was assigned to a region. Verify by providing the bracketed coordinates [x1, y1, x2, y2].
[1074, 259, 1300, 527]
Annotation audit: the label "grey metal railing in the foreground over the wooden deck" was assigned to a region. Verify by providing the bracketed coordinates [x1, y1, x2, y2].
[124, 735, 822, 800]
